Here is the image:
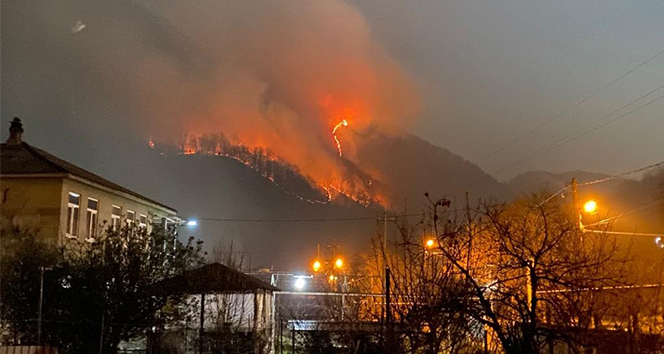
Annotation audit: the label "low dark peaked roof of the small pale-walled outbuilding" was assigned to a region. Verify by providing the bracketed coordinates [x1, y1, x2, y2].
[159, 263, 279, 294]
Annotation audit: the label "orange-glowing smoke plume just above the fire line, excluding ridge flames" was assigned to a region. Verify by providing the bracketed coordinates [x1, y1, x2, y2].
[152, 1, 418, 198]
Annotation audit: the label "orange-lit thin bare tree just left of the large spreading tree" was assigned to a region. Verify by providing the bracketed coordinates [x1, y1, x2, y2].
[378, 215, 482, 354]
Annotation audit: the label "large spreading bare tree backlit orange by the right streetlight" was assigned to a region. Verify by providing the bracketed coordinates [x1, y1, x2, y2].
[420, 196, 625, 353]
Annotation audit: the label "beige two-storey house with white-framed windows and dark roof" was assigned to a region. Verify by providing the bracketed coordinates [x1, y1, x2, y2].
[0, 118, 178, 244]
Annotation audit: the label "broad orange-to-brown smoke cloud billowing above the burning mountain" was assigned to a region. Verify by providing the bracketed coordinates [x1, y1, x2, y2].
[54, 0, 420, 207]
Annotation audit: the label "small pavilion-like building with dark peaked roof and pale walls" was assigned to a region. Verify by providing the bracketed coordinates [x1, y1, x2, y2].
[154, 263, 278, 354]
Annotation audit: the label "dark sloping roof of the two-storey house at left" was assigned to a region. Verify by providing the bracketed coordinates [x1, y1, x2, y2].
[0, 142, 176, 212]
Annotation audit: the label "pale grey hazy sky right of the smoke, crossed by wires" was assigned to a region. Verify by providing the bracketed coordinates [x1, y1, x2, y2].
[353, 0, 664, 179]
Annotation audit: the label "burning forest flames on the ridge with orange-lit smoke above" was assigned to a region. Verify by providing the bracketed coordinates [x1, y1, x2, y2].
[124, 0, 422, 213]
